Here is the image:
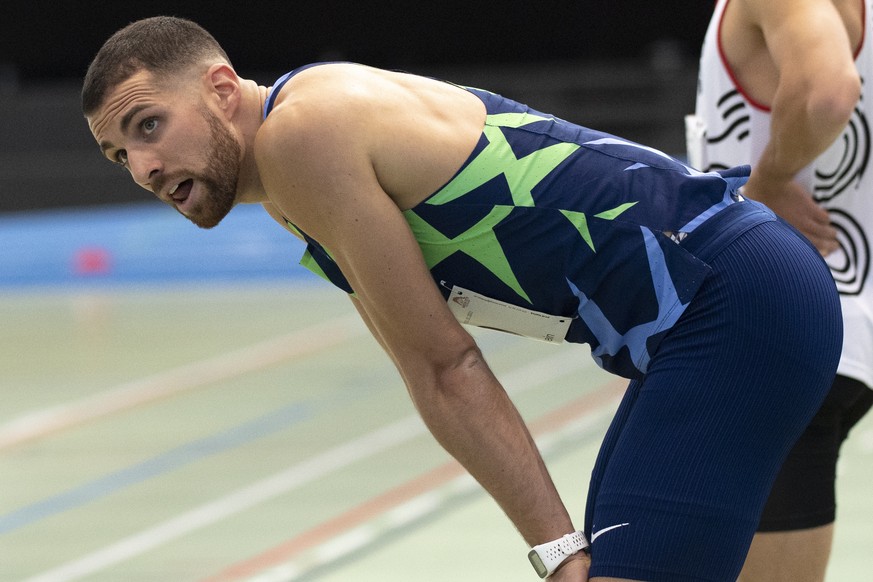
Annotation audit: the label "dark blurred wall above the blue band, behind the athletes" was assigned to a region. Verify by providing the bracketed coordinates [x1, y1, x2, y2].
[0, 0, 713, 211]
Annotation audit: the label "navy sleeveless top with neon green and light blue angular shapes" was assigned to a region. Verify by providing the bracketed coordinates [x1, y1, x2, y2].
[262, 67, 748, 377]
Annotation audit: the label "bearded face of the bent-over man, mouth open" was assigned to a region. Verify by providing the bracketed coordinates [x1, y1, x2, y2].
[88, 71, 241, 228]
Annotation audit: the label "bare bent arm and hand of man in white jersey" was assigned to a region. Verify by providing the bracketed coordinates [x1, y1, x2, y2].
[722, 0, 860, 253]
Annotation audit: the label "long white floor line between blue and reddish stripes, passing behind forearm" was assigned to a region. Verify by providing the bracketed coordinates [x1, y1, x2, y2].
[24, 352, 593, 582]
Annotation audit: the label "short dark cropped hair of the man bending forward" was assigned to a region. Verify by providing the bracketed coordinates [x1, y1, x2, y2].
[82, 16, 230, 115]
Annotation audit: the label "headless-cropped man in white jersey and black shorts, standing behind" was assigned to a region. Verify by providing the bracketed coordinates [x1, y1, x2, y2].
[689, 0, 873, 582]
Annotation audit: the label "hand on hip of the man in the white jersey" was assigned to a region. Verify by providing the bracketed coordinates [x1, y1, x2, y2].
[743, 180, 839, 256]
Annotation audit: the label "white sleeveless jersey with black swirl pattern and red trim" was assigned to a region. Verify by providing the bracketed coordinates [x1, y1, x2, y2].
[686, 0, 873, 387]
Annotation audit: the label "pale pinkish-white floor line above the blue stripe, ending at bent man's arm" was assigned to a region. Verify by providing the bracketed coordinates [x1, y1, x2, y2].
[0, 315, 368, 450]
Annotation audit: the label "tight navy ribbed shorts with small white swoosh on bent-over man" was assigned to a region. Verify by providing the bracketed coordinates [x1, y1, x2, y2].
[585, 201, 842, 582]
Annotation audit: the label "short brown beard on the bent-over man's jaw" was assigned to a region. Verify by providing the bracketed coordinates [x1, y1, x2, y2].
[177, 108, 241, 228]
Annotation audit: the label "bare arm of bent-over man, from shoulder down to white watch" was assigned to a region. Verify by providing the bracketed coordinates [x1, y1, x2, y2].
[257, 67, 573, 564]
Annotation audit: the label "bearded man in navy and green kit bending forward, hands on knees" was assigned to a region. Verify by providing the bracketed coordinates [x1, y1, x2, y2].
[82, 17, 842, 582]
